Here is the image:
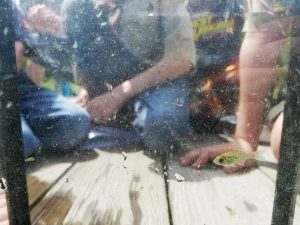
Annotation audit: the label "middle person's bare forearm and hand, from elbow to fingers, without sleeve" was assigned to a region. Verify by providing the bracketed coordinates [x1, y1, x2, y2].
[87, 58, 192, 123]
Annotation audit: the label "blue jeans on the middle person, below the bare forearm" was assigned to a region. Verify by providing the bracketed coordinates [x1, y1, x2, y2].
[133, 79, 193, 152]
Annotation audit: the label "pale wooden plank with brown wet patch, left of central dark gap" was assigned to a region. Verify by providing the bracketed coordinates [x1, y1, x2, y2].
[32, 151, 169, 225]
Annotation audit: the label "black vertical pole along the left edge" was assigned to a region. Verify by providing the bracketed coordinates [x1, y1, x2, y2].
[0, 0, 30, 225]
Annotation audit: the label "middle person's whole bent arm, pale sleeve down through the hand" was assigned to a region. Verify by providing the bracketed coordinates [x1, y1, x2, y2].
[87, 4, 195, 123]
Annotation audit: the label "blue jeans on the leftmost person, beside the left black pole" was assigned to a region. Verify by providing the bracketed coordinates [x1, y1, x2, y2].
[19, 71, 90, 157]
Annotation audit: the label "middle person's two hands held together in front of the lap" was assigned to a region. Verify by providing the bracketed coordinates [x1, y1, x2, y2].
[73, 89, 124, 124]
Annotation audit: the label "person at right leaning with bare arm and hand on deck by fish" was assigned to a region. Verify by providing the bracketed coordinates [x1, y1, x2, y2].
[180, 0, 300, 173]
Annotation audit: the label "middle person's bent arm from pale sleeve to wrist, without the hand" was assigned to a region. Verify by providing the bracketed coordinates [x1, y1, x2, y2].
[113, 1, 196, 104]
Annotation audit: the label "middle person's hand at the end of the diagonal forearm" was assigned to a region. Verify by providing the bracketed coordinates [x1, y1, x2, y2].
[87, 92, 124, 124]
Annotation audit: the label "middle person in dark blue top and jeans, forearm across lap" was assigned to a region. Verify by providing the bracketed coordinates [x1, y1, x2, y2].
[65, 0, 195, 152]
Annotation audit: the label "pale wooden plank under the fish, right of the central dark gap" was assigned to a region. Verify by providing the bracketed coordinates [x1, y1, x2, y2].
[167, 141, 300, 225]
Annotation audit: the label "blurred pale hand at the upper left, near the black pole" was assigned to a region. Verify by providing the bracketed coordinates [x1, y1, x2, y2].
[26, 4, 64, 36]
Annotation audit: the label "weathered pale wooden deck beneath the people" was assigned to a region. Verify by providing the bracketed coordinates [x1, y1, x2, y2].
[28, 135, 300, 225]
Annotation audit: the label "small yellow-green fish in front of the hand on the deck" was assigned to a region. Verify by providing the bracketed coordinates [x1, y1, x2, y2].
[213, 150, 257, 167]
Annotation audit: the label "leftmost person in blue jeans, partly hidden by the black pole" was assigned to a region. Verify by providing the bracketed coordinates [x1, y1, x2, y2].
[0, 1, 90, 225]
